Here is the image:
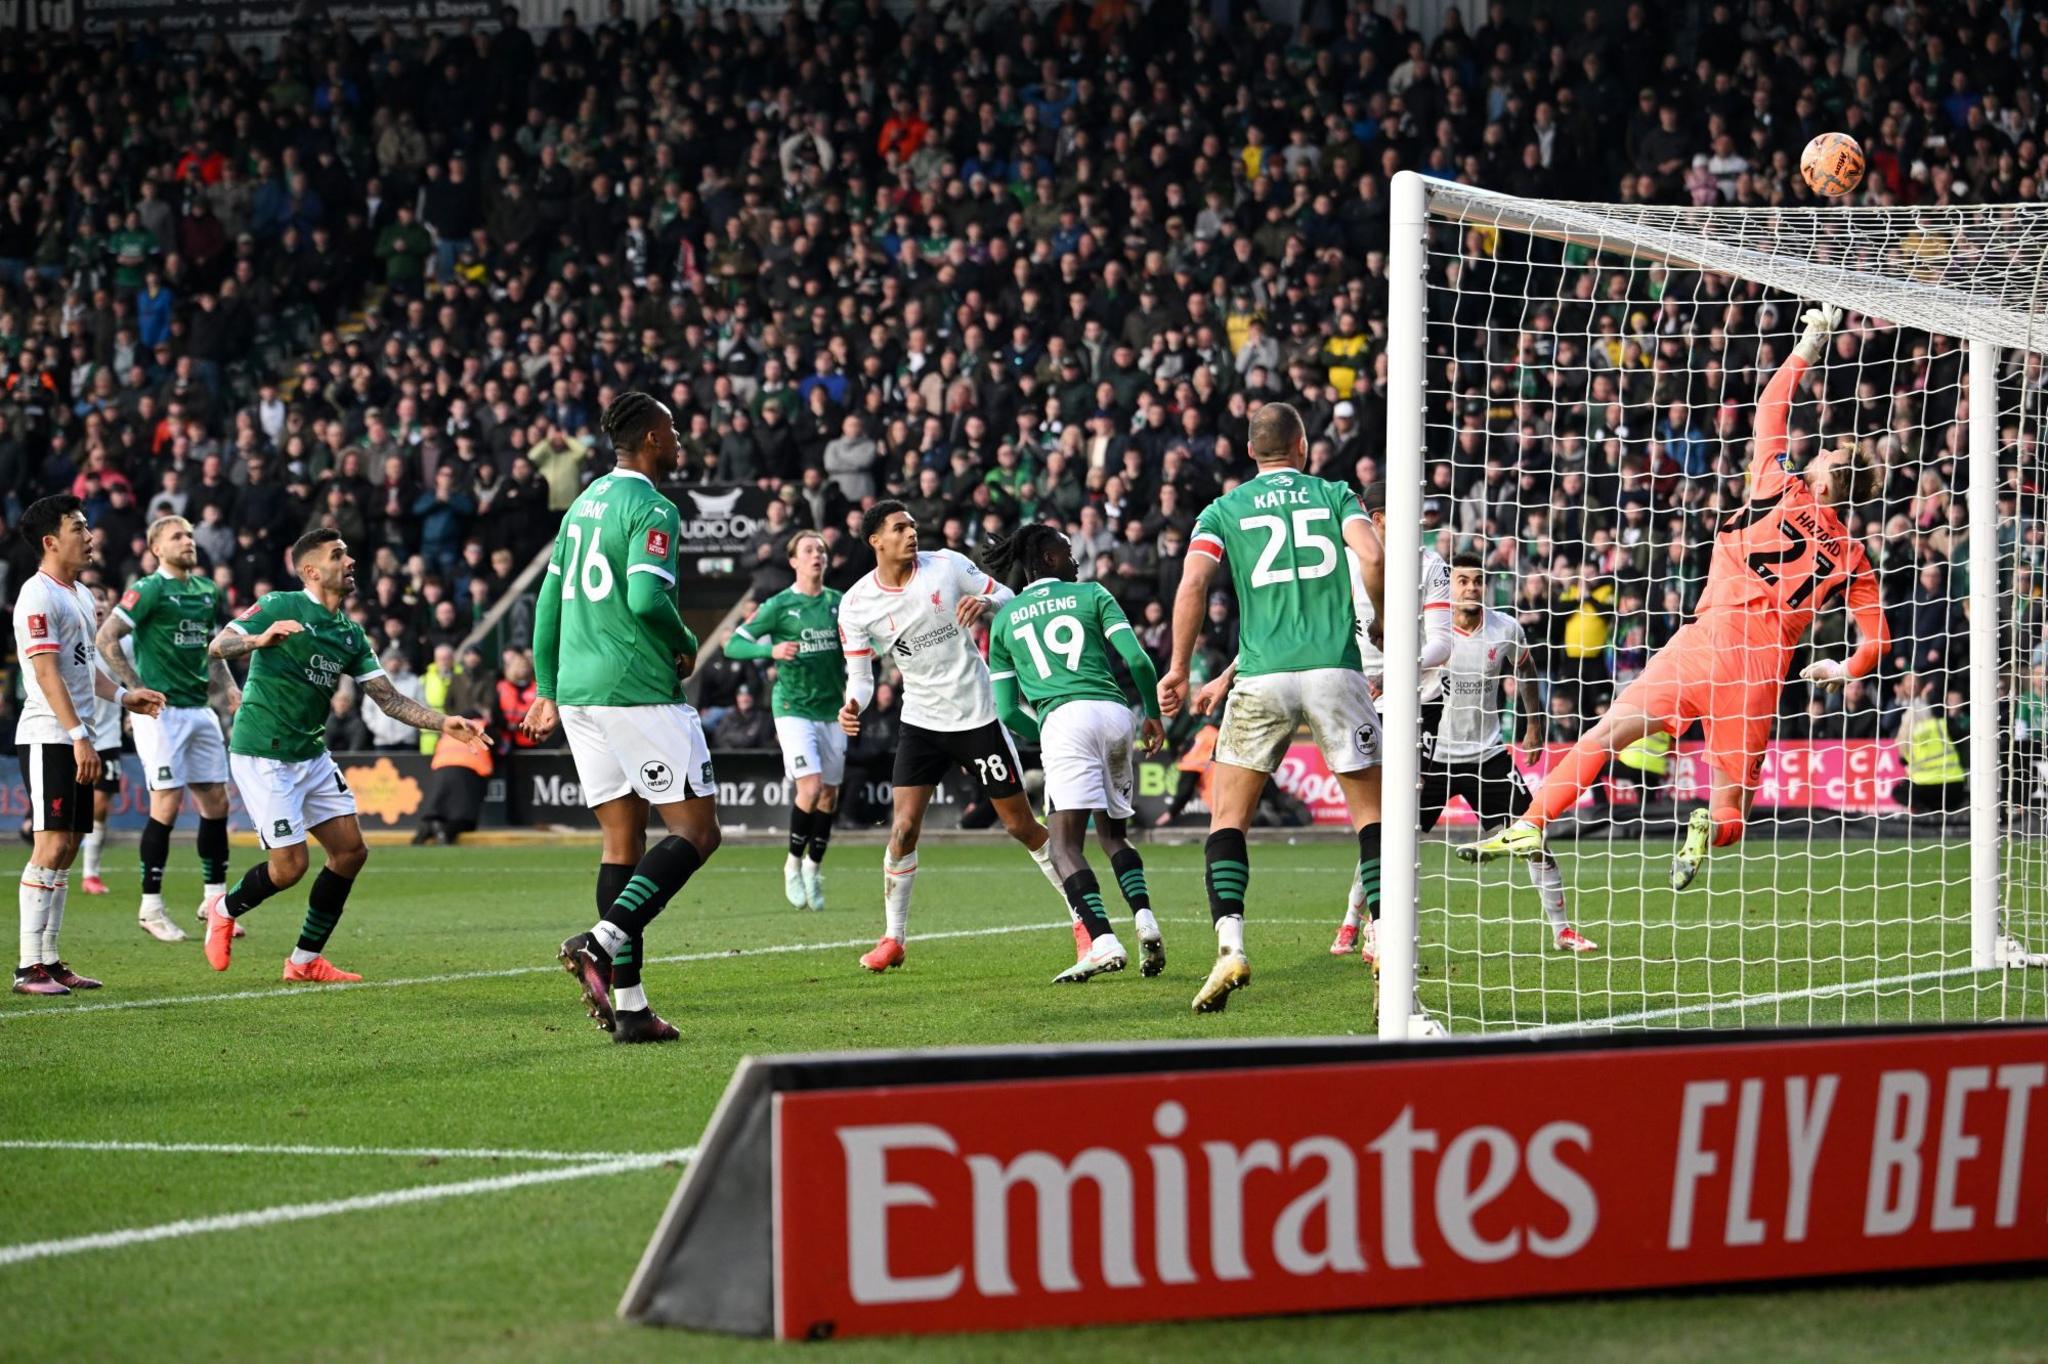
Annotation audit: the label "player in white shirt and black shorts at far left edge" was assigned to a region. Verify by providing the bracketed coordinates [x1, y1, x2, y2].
[14, 496, 164, 995]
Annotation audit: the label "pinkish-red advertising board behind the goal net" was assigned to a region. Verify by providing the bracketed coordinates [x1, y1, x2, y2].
[1274, 739, 1907, 825]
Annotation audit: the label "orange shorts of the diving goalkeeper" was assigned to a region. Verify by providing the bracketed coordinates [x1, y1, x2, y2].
[1622, 621, 1792, 786]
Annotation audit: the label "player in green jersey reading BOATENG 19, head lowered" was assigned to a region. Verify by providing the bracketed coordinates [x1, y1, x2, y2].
[983, 524, 1165, 983]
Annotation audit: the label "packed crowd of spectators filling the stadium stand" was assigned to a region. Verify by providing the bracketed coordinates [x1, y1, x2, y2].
[0, 0, 2048, 786]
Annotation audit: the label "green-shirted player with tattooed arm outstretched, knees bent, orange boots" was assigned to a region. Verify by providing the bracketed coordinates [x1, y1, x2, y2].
[207, 530, 487, 983]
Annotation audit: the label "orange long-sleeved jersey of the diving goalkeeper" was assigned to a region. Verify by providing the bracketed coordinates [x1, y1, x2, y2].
[1698, 354, 1886, 676]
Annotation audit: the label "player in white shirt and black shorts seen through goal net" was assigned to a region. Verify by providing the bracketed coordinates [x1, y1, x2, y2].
[1421, 555, 1597, 952]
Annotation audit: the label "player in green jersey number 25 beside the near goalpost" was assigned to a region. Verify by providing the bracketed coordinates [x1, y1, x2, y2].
[1159, 403, 1386, 1014]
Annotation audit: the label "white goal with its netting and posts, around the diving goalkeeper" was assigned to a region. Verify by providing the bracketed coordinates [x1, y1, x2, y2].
[1380, 176, 2048, 1036]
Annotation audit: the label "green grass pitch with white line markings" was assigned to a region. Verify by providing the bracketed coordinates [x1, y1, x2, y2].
[0, 840, 2048, 1364]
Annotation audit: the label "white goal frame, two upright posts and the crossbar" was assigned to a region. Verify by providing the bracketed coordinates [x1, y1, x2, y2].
[1376, 170, 2007, 1040]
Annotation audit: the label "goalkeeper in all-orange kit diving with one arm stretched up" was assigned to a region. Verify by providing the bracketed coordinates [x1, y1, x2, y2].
[1458, 307, 1888, 891]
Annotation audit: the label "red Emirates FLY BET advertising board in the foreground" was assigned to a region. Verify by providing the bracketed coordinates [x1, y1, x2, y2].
[621, 1026, 2048, 1339]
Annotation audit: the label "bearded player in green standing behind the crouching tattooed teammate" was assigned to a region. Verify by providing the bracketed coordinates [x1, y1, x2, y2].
[94, 516, 242, 942]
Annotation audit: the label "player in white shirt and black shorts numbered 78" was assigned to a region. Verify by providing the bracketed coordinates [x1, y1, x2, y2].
[840, 500, 1067, 971]
